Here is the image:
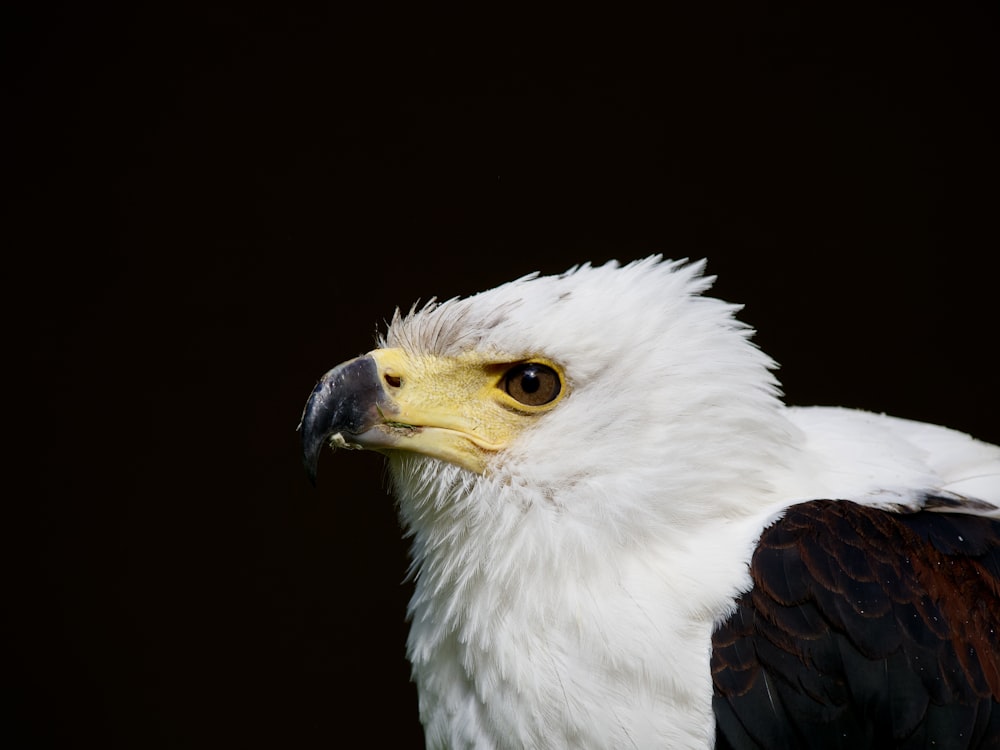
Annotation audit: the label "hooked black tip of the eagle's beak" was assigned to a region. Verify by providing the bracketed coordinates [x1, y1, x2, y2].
[298, 355, 384, 485]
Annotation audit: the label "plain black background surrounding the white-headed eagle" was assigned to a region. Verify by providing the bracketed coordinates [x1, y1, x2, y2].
[9, 2, 1000, 748]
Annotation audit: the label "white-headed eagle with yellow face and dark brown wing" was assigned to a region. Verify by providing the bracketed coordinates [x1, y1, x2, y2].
[299, 255, 1000, 750]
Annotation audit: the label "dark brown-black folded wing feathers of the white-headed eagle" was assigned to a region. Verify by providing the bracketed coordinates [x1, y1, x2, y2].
[712, 500, 1000, 750]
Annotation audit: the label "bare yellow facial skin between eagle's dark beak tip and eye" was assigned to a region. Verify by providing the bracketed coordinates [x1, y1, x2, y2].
[359, 349, 569, 474]
